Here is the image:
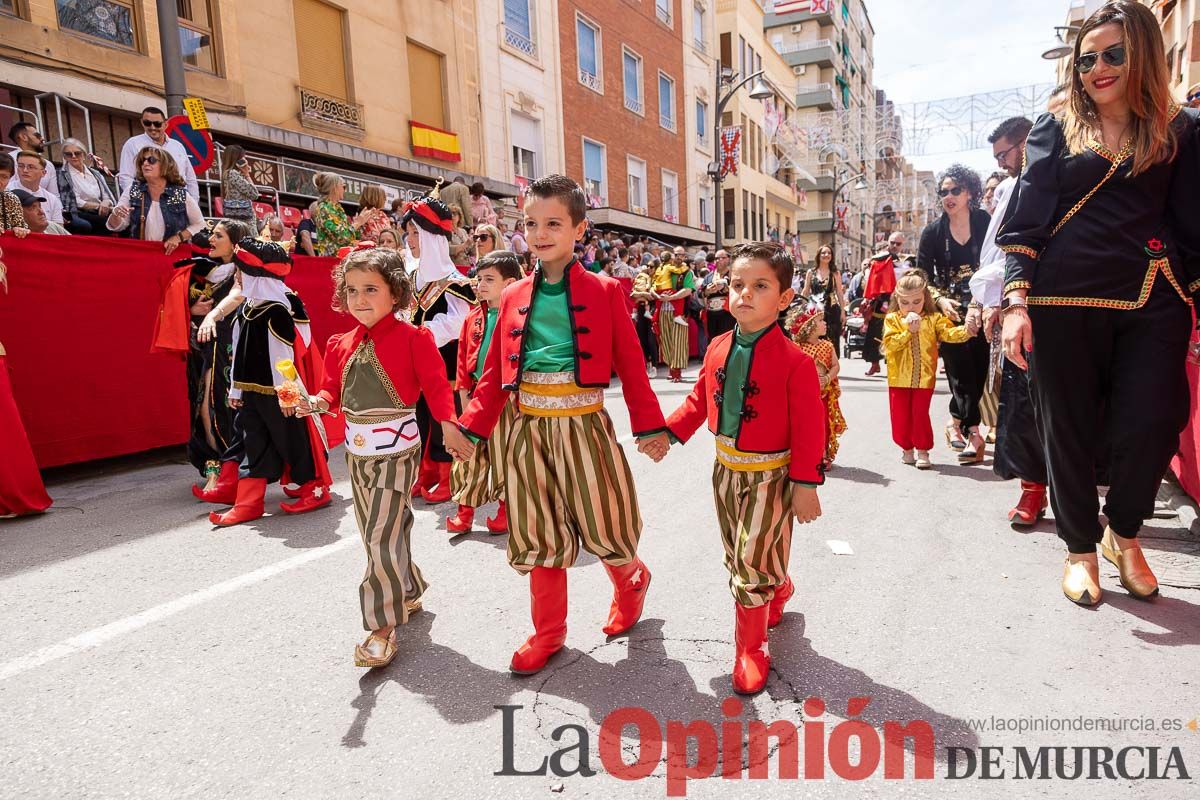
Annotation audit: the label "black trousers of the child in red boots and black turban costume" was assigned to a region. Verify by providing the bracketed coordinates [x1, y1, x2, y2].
[234, 392, 317, 483]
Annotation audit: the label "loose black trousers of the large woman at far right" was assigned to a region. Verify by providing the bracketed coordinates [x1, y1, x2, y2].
[1030, 283, 1192, 553]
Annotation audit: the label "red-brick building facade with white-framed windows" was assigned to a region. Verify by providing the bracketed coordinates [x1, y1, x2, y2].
[558, 0, 712, 243]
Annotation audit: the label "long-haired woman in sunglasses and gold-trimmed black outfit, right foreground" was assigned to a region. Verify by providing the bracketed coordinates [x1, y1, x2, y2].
[998, 0, 1200, 606]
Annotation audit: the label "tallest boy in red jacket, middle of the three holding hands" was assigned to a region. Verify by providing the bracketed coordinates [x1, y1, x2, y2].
[458, 175, 670, 675]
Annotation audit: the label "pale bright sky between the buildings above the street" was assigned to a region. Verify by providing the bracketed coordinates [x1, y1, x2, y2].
[866, 0, 1070, 172]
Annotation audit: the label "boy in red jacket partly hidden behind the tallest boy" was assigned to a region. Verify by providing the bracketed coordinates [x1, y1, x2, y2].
[446, 249, 524, 535]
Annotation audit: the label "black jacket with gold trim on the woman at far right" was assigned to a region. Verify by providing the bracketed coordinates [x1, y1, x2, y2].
[997, 109, 1200, 309]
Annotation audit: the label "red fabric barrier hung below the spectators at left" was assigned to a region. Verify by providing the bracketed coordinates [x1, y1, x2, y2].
[0, 234, 354, 469]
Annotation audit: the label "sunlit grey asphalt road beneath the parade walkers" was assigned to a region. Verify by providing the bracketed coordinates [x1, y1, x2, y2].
[0, 361, 1200, 800]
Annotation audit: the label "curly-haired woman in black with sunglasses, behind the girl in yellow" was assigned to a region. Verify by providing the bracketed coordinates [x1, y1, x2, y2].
[917, 164, 991, 464]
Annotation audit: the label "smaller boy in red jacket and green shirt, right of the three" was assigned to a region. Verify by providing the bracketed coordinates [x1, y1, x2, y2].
[667, 242, 824, 694]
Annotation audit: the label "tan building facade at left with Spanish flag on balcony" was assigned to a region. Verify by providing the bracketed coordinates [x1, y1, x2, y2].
[0, 0, 516, 217]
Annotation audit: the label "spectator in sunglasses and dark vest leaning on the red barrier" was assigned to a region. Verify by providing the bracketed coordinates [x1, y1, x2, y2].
[104, 148, 205, 255]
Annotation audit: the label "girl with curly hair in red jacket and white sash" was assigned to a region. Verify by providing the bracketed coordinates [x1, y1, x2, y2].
[300, 246, 472, 667]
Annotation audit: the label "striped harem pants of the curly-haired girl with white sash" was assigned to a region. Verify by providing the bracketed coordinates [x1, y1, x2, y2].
[346, 447, 428, 631]
